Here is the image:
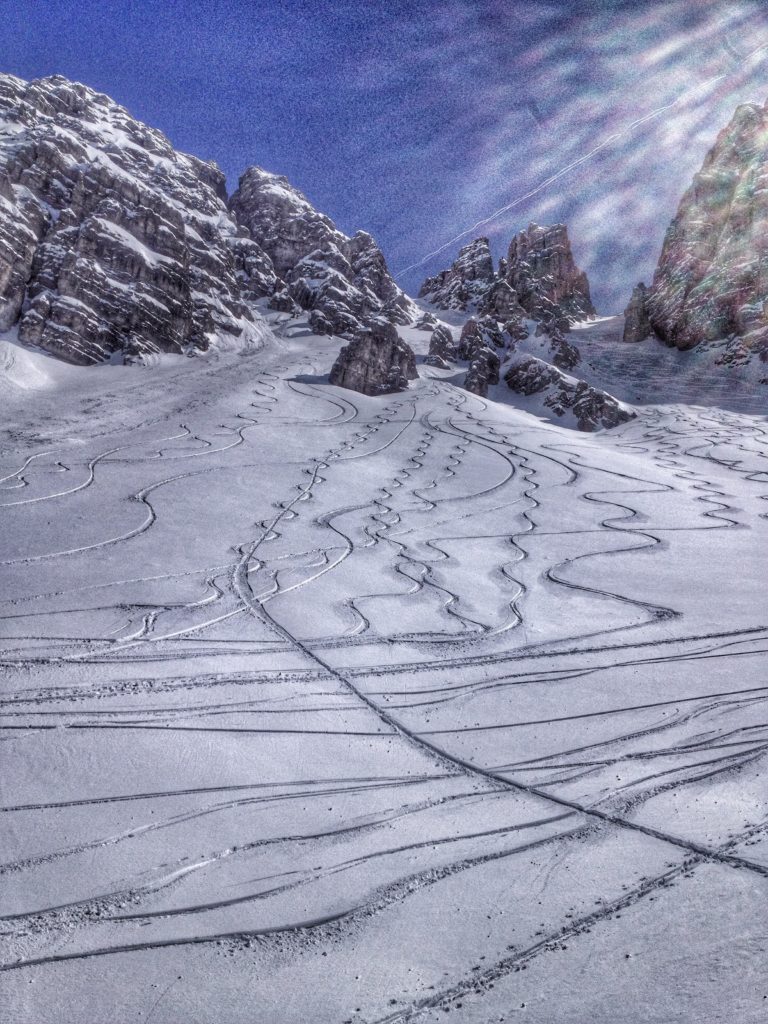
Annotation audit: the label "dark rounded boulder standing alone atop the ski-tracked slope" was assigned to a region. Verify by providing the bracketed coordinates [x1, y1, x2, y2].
[329, 321, 419, 395]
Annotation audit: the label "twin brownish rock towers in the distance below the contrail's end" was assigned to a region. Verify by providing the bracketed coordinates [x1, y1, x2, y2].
[419, 224, 595, 331]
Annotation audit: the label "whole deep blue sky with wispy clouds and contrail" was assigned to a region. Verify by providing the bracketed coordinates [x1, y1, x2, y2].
[0, 0, 768, 312]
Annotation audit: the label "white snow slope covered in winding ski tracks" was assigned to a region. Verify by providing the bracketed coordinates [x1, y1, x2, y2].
[0, 321, 768, 1024]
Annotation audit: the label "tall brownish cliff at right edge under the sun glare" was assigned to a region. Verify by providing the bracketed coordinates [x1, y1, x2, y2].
[646, 103, 768, 353]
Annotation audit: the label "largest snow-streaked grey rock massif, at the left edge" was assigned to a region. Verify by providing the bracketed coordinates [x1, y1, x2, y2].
[0, 75, 273, 364]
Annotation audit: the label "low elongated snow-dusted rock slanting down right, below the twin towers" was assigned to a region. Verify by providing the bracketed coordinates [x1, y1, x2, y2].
[504, 355, 635, 431]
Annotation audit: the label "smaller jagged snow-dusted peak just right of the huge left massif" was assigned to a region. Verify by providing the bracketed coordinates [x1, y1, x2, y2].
[229, 167, 421, 335]
